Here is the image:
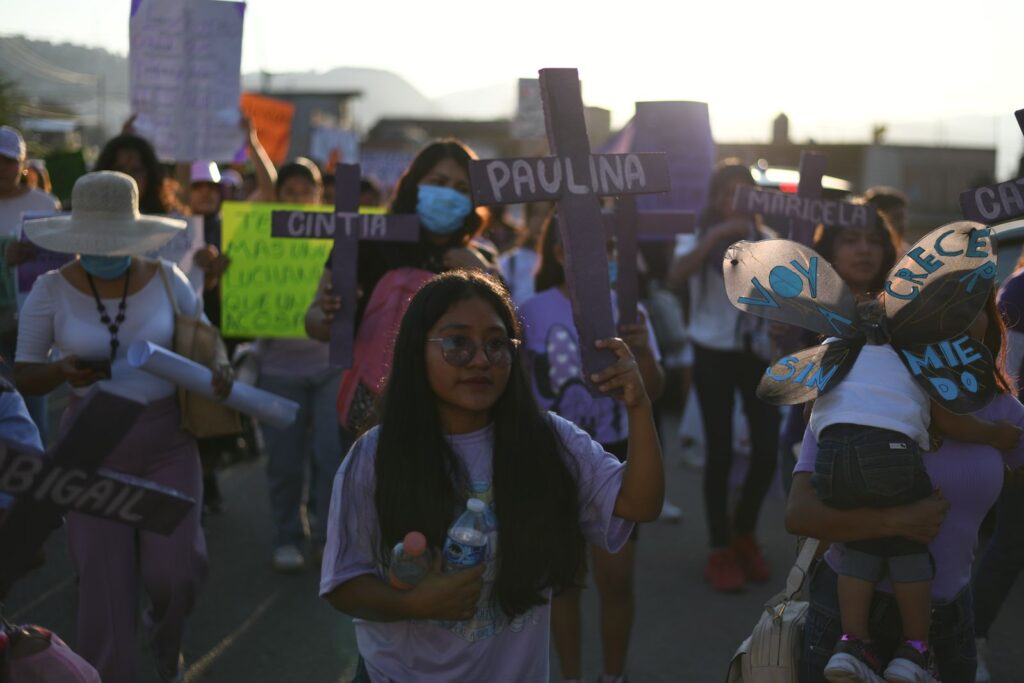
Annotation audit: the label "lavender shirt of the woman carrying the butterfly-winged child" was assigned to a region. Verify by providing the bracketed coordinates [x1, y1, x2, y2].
[793, 394, 1024, 602]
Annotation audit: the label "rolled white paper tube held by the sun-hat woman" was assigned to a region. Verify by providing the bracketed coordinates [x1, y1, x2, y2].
[128, 341, 299, 429]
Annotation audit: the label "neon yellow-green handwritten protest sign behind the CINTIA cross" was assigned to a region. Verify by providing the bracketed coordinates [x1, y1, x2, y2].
[220, 202, 331, 339]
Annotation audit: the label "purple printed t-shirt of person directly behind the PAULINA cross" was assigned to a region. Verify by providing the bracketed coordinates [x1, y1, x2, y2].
[519, 287, 662, 444]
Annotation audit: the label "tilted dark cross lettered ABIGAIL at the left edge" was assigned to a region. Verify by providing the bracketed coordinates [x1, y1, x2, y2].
[0, 387, 196, 577]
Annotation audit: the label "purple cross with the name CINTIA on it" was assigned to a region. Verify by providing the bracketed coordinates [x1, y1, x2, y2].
[270, 164, 420, 368]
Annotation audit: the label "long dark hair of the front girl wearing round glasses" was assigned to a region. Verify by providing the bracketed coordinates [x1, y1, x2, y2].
[374, 270, 584, 616]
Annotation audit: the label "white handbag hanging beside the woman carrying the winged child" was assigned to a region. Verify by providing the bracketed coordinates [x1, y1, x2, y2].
[725, 539, 818, 683]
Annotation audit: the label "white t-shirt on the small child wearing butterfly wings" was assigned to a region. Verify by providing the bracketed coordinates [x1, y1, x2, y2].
[810, 344, 932, 451]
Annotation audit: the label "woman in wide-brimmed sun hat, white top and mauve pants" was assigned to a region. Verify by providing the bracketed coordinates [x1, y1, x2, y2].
[15, 171, 229, 683]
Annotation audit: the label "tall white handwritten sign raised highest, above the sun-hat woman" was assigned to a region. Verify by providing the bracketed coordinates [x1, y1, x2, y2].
[128, 0, 246, 162]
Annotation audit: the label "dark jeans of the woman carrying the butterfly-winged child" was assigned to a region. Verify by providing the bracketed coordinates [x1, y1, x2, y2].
[799, 561, 978, 683]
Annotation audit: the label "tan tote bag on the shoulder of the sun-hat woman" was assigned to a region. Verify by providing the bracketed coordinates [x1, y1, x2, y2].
[158, 261, 242, 438]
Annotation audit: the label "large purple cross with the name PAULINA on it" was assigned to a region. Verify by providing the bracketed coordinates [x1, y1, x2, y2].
[469, 69, 669, 384]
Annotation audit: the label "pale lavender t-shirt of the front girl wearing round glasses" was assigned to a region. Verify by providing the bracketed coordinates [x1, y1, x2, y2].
[321, 414, 633, 683]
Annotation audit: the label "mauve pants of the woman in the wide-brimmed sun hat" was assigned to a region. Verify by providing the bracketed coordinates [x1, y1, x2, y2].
[61, 397, 206, 683]
